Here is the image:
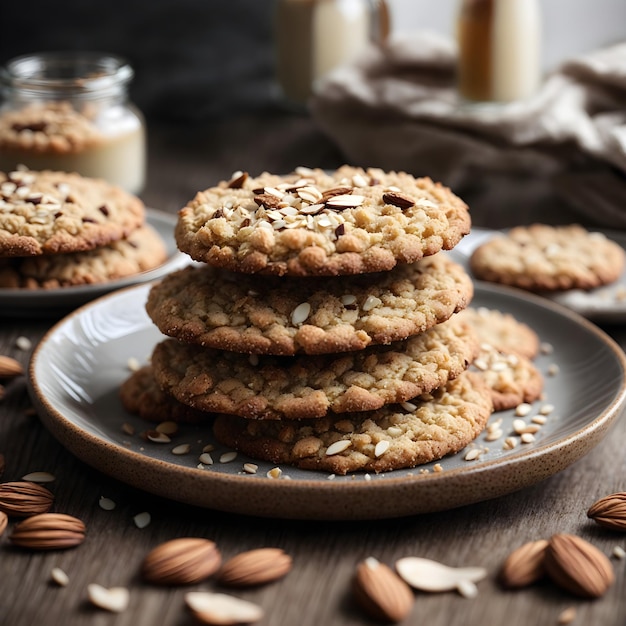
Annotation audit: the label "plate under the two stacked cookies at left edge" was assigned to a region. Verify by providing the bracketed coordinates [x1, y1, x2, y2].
[0, 209, 191, 318]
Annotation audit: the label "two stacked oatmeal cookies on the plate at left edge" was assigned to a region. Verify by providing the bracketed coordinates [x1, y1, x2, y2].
[0, 169, 167, 289]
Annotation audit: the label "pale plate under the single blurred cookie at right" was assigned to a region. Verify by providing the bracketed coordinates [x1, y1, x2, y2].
[448, 227, 626, 322]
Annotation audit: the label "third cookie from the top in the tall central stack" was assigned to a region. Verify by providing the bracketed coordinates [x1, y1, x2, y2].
[151, 318, 478, 419]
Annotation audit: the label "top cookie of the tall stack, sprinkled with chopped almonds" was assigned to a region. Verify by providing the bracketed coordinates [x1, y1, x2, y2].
[176, 166, 470, 276]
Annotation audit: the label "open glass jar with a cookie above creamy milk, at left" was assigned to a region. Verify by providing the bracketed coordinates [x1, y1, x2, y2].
[0, 52, 146, 193]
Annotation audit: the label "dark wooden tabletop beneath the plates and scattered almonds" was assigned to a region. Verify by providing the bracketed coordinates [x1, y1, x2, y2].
[0, 115, 626, 626]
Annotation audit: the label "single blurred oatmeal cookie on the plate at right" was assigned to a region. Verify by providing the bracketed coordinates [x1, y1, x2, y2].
[470, 224, 625, 291]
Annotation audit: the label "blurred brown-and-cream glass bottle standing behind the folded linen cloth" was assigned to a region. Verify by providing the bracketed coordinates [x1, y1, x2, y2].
[456, 0, 541, 102]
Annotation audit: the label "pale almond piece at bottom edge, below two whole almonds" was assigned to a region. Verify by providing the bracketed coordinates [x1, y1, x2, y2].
[185, 591, 263, 624]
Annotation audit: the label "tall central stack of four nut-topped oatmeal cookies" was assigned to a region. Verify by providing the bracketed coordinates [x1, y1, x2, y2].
[127, 166, 493, 474]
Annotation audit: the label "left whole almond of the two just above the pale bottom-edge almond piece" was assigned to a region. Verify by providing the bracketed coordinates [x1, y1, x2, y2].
[142, 537, 222, 585]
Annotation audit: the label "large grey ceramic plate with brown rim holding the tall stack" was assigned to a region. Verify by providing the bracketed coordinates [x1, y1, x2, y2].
[29, 285, 626, 519]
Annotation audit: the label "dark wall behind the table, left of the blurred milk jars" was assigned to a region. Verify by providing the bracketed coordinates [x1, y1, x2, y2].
[0, 0, 279, 123]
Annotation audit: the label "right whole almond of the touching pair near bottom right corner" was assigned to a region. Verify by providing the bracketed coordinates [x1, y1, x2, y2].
[544, 534, 615, 598]
